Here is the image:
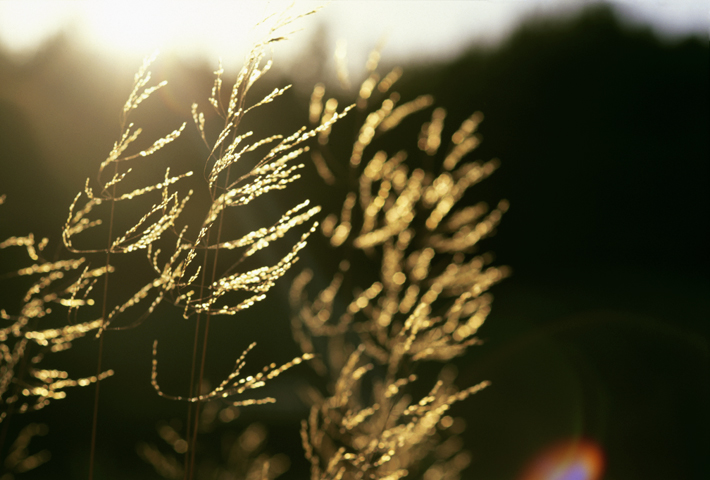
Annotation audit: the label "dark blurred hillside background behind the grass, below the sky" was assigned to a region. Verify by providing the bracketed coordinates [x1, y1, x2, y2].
[0, 7, 710, 480]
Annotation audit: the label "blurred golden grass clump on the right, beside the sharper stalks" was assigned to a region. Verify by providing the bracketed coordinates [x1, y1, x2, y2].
[290, 43, 509, 480]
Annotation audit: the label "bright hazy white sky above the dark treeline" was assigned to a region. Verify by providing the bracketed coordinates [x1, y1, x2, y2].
[0, 0, 710, 71]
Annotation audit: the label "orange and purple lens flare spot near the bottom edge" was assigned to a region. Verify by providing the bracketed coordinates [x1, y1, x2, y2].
[521, 439, 604, 480]
